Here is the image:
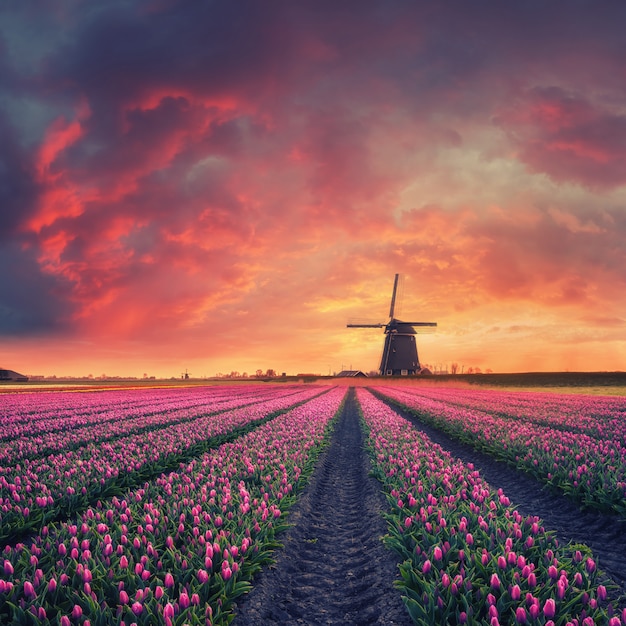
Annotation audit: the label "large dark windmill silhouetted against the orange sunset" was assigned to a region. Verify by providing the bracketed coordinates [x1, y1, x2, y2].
[347, 274, 437, 376]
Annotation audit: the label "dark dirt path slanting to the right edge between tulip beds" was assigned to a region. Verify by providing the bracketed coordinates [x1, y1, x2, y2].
[393, 398, 626, 594]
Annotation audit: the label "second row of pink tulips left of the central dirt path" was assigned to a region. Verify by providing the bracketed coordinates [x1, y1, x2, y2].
[0, 386, 330, 542]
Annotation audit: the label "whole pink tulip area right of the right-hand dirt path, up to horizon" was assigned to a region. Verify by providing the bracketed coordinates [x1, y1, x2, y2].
[370, 387, 626, 518]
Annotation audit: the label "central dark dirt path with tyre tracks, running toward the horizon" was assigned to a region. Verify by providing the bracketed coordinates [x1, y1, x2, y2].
[233, 390, 412, 626]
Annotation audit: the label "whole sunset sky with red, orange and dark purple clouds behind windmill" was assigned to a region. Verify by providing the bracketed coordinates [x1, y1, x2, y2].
[0, 0, 626, 377]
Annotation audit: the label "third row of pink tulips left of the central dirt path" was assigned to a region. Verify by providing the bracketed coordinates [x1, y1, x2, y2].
[0, 387, 302, 467]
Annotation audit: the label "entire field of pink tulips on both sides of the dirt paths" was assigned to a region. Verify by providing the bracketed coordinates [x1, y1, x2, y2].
[0, 384, 626, 626]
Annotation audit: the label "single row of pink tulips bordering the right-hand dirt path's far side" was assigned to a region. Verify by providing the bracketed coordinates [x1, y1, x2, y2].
[378, 387, 626, 517]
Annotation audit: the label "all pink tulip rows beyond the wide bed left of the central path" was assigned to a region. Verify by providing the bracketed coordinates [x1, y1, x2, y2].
[0, 382, 326, 540]
